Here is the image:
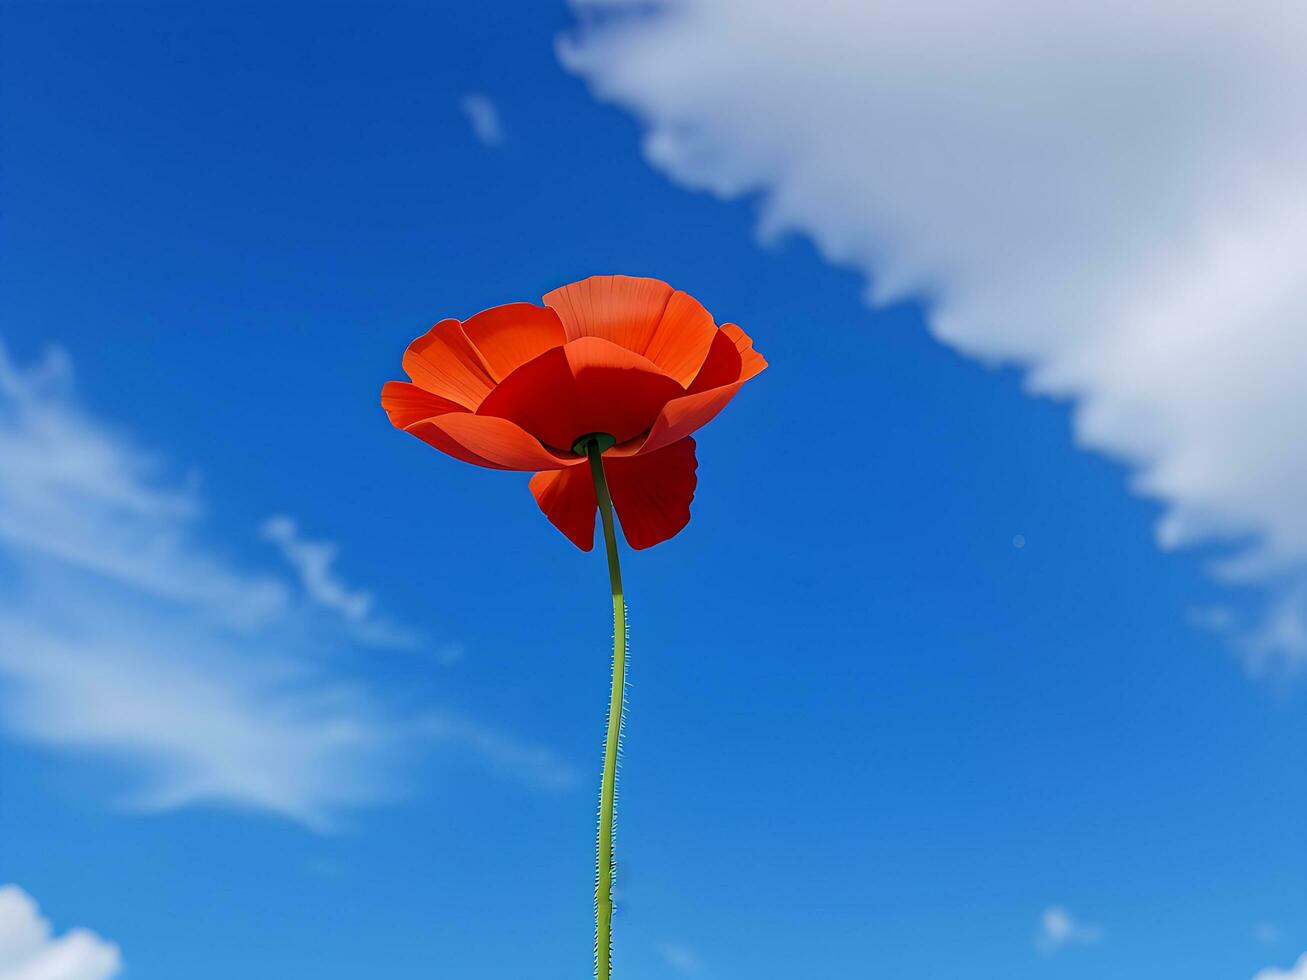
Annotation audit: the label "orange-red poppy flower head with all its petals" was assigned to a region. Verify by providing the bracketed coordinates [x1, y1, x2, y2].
[382, 276, 767, 551]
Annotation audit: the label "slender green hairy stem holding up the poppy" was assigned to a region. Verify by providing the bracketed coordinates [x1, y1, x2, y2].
[586, 440, 626, 980]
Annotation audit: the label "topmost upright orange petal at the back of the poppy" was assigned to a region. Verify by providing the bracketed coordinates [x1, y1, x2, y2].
[545, 276, 716, 387]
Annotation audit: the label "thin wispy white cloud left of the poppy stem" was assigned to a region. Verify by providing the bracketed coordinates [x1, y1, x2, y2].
[0, 346, 570, 830]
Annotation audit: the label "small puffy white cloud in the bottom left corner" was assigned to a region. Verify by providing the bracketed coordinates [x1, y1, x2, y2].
[0, 885, 122, 980]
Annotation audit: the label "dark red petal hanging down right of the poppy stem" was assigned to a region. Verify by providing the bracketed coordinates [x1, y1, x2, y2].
[606, 439, 698, 550]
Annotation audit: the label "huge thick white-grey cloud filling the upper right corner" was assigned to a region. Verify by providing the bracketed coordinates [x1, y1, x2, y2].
[559, 0, 1307, 662]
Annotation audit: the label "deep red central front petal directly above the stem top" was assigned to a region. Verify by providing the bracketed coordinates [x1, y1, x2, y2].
[477, 337, 684, 449]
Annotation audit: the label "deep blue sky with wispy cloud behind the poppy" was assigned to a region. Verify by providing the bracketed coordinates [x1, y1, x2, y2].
[0, 3, 1307, 980]
